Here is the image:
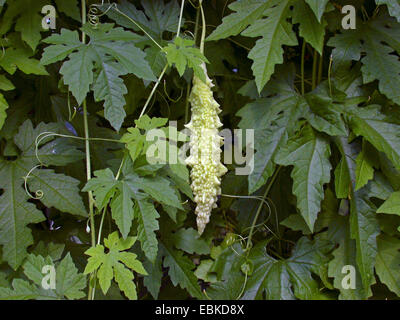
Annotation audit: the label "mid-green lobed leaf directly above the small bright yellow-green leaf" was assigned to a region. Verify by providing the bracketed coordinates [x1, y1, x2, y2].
[82, 168, 182, 262]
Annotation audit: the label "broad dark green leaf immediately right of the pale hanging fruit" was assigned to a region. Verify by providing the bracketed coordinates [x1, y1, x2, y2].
[236, 66, 305, 194]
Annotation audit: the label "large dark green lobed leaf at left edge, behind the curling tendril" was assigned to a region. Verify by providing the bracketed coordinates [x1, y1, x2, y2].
[0, 120, 87, 269]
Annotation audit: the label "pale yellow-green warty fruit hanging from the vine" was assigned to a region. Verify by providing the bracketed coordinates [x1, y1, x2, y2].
[186, 64, 227, 234]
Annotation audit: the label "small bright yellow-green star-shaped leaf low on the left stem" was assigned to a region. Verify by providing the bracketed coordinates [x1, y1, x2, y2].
[84, 231, 147, 300]
